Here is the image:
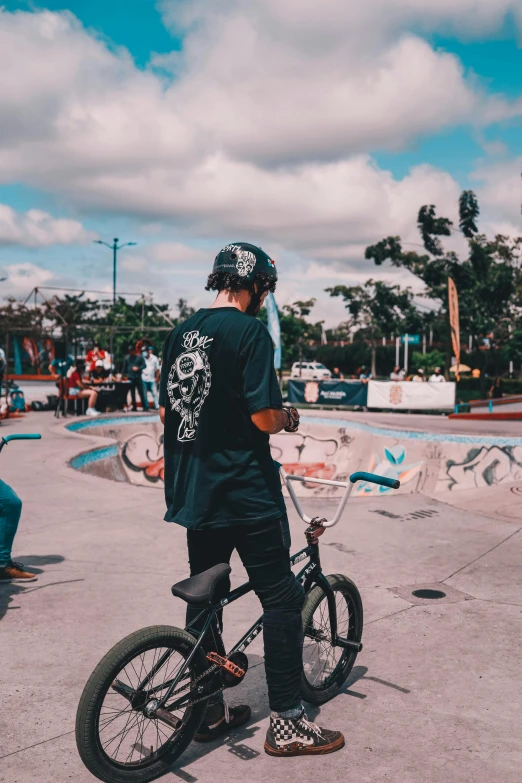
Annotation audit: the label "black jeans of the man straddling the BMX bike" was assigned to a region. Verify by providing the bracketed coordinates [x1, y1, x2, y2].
[187, 518, 304, 712]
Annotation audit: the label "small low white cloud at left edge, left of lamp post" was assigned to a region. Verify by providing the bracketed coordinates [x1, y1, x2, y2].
[0, 204, 96, 247]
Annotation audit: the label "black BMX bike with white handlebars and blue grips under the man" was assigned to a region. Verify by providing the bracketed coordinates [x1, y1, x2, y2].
[76, 463, 400, 783]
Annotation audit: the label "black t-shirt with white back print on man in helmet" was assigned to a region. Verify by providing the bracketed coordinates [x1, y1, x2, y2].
[160, 307, 286, 528]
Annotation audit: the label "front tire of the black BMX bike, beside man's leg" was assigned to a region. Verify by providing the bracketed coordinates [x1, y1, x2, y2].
[301, 574, 363, 704]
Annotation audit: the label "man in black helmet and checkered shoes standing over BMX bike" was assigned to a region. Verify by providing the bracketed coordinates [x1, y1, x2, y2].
[160, 242, 344, 756]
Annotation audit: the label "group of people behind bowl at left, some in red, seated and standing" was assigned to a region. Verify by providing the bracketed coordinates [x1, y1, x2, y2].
[49, 343, 160, 416]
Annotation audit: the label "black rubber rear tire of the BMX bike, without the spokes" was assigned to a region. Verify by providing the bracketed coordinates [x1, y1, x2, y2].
[76, 625, 206, 783]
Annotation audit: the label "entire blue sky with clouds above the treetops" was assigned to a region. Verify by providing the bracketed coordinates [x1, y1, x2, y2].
[0, 0, 522, 327]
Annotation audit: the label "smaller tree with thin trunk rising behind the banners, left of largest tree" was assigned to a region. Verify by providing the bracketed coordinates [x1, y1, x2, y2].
[325, 280, 420, 377]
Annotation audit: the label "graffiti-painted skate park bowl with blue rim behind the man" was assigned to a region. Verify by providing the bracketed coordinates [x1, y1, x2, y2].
[66, 410, 522, 498]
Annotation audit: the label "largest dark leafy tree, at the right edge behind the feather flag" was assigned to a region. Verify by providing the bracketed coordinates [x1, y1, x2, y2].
[365, 191, 522, 348]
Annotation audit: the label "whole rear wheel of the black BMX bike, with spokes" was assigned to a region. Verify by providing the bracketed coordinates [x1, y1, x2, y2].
[76, 626, 206, 783]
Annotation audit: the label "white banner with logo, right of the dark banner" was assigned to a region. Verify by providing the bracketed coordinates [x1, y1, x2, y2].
[367, 381, 456, 411]
